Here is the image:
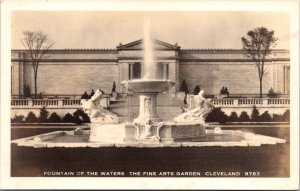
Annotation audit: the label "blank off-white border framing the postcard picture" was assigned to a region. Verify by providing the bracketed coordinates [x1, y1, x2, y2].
[0, 0, 299, 189]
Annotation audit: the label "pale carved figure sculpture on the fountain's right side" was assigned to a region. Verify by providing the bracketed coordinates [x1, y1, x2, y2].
[174, 90, 214, 124]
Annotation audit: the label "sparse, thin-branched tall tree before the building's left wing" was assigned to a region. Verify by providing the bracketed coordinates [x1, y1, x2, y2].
[21, 31, 54, 98]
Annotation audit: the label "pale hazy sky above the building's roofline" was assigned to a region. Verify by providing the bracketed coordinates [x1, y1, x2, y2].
[11, 11, 290, 49]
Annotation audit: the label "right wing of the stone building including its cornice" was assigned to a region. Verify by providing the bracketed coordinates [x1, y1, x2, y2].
[179, 49, 290, 95]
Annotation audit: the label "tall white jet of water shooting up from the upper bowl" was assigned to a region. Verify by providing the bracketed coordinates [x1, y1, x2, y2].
[143, 17, 157, 80]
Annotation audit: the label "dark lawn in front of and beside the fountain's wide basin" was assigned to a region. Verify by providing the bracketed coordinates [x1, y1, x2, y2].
[11, 127, 290, 177]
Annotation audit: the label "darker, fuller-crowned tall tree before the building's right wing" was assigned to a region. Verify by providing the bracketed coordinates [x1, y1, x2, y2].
[241, 27, 277, 98]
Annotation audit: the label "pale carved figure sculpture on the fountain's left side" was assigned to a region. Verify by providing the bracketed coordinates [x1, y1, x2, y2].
[81, 89, 119, 123]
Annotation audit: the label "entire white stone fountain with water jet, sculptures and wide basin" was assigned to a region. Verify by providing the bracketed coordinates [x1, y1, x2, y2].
[13, 18, 285, 147]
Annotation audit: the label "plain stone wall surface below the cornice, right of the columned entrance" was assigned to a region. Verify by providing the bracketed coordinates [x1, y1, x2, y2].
[179, 62, 283, 95]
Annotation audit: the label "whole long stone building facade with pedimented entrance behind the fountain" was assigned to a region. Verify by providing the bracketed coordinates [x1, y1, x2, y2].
[11, 40, 290, 98]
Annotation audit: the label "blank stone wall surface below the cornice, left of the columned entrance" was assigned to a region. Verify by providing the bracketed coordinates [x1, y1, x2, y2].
[24, 62, 119, 95]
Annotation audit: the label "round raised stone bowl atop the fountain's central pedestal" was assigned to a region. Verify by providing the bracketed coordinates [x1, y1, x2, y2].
[121, 79, 175, 93]
